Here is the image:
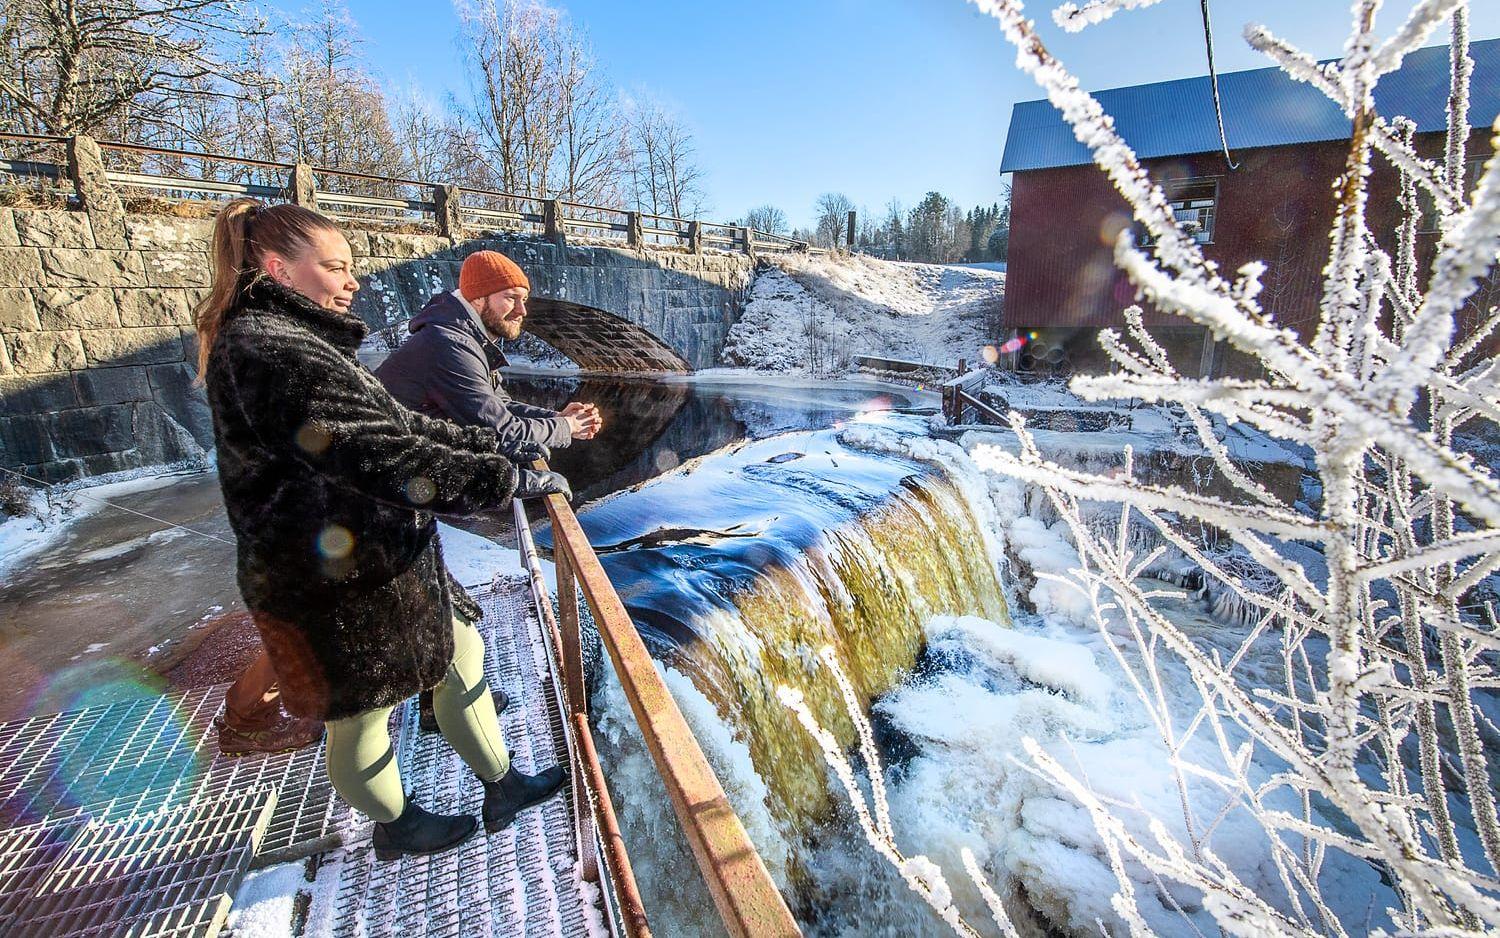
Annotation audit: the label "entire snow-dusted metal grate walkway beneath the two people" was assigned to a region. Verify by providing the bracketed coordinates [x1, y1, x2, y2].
[0, 578, 603, 938]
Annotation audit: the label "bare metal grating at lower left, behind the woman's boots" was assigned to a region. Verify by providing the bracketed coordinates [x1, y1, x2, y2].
[0, 675, 350, 938]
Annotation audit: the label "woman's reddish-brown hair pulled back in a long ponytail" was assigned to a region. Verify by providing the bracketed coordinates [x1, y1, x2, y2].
[194, 198, 339, 384]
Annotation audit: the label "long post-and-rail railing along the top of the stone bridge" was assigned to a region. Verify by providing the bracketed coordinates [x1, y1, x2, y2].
[0, 134, 827, 254]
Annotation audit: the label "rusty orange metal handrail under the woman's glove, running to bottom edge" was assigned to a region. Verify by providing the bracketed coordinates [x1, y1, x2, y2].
[546, 483, 801, 938]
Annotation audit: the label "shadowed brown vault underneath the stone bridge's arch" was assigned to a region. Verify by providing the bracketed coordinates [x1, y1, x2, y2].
[525, 296, 693, 372]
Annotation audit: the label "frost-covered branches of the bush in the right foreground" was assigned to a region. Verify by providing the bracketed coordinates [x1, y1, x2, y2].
[972, 0, 1500, 935]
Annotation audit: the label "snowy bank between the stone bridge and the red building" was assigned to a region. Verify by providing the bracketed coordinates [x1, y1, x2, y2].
[723, 255, 1005, 374]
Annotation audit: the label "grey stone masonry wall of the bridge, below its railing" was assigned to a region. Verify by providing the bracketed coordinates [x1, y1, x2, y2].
[0, 201, 753, 480]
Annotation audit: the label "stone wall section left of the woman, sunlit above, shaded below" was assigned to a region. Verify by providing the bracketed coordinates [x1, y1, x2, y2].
[0, 209, 213, 480]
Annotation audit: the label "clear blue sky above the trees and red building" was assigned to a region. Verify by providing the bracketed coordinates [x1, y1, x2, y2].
[276, 0, 1500, 224]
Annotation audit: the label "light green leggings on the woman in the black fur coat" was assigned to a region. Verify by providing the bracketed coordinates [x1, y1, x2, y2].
[326, 615, 510, 822]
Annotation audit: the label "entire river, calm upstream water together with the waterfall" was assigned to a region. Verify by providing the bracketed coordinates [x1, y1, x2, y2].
[0, 374, 1044, 935]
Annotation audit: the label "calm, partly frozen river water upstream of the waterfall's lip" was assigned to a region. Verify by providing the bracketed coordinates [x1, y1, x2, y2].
[0, 374, 932, 720]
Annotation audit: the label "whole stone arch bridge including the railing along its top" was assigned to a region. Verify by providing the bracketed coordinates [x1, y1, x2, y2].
[0, 135, 785, 482]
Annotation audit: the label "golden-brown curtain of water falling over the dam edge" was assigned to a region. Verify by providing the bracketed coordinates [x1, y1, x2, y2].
[674, 474, 1005, 828]
